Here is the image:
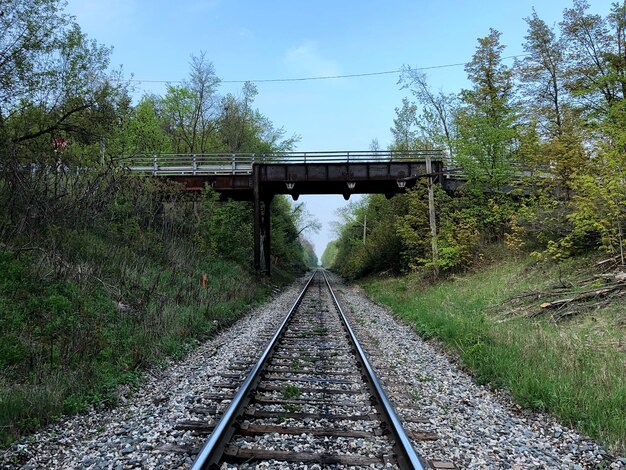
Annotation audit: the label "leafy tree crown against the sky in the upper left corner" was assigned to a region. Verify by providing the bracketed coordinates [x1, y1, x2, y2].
[0, 0, 128, 163]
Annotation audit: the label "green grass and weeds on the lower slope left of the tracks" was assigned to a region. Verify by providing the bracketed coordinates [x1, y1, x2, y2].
[0, 231, 278, 445]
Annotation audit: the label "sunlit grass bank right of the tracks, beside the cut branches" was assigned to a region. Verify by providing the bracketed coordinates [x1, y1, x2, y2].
[363, 255, 626, 454]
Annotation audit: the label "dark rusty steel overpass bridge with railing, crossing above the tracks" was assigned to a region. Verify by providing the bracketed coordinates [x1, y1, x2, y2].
[123, 150, 444, 275]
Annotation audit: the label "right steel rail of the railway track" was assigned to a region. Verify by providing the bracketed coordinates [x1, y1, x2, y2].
[322, 271, 430, 470]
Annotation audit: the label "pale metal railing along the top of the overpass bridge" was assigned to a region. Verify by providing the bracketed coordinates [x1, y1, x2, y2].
[121, 150, 443, 175]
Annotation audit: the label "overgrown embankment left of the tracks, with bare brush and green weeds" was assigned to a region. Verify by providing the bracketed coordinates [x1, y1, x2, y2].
[0, 166, 312, 447]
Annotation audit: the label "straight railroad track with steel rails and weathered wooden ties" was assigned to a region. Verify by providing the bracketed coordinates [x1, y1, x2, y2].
[179, 270, 454, 470]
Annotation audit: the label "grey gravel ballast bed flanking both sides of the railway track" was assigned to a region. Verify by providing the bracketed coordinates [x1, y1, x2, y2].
[0, 279, 626, 470]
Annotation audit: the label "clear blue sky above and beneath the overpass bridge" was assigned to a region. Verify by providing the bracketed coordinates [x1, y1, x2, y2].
[67, 0, 611, 256]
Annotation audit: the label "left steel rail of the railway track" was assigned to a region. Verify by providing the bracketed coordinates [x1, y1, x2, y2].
[191, 273, 315, 470]
